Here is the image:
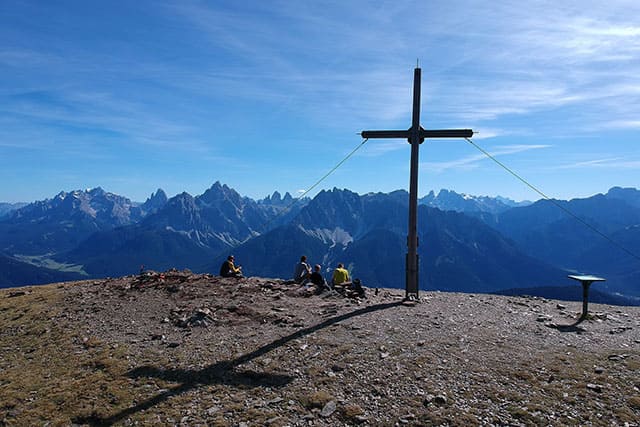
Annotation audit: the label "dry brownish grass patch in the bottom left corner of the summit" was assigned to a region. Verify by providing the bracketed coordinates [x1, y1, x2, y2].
[0, 285, 171, 425]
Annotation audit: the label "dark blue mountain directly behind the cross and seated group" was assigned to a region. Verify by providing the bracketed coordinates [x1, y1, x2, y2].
[214, 188, 564, 292]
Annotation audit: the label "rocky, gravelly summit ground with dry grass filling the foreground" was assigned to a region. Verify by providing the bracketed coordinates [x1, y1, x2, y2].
[0, 271, 640, 427]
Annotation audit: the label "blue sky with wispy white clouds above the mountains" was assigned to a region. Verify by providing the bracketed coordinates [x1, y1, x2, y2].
[0, 0, 640, 202]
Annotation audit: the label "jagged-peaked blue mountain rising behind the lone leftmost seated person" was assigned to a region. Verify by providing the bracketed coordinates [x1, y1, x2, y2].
[56, 182, 308, 275]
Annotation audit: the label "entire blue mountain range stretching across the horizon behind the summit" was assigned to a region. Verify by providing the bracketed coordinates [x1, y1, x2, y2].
[0, 182, 640, 304]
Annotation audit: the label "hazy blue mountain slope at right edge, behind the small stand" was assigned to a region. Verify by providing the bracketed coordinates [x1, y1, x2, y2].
[483, 188, 640, 296]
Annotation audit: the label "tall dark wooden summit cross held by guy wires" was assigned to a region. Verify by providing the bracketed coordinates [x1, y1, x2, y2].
[361, 67, 473, 299]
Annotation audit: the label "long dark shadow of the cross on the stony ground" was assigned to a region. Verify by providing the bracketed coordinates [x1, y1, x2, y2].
[73, 301, 402, 426]
